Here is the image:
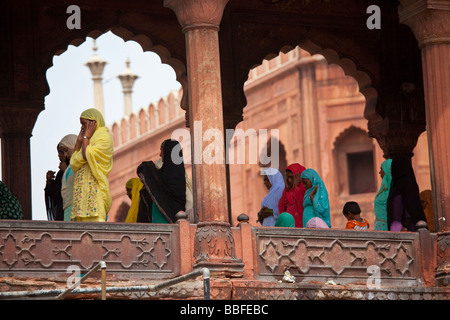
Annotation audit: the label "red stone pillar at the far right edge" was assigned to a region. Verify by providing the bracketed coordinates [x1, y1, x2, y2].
[399, 0, 450, 285]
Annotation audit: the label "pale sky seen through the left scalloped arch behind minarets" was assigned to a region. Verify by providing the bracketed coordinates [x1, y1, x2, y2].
[0, 32, 181, 220]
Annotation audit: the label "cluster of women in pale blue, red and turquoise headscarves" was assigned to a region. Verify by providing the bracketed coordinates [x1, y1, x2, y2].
[258, 163, 331, 228]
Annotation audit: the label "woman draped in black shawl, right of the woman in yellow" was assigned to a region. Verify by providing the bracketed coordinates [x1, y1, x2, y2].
[137, 139, 186, 223]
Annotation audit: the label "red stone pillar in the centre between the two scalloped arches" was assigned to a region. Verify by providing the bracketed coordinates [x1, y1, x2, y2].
[164, 0, 243, 276]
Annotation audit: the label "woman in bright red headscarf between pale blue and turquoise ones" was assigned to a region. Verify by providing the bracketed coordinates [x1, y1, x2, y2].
[278, 163, 306, 228]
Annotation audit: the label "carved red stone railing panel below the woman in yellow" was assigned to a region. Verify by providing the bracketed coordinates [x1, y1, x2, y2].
[0, 221, 180, 279]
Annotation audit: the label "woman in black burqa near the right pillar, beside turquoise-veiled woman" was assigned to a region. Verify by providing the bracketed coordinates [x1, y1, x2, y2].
[387, 157, 426, 231]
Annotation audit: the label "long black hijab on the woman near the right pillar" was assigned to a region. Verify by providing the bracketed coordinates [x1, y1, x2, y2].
[387, 157, 426, 230]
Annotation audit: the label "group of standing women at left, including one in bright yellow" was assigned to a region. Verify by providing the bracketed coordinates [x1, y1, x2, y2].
[45, 108, 114, 222]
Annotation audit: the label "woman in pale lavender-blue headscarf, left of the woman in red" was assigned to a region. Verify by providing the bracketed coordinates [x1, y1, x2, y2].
[258, 168, 285, 227]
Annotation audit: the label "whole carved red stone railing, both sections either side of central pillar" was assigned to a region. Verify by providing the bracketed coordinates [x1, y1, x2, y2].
[0, 219, 438, 290]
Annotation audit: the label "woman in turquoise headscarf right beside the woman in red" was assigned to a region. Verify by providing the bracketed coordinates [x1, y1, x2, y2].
[301, 169, 331, 228]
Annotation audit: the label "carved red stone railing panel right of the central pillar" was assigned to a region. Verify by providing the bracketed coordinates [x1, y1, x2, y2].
[252, 228, 435, 287]
